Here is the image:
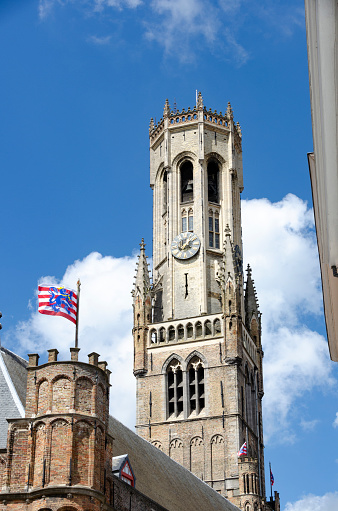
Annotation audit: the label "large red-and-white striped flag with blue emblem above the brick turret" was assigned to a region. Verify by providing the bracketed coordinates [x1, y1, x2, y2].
[38, 284, 77, 324]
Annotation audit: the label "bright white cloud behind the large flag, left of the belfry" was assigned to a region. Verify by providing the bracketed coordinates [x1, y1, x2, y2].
[8, 253, 136, 427]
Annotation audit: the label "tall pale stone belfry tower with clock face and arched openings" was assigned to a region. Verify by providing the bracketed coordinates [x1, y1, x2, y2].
[133, 93, 279, 511]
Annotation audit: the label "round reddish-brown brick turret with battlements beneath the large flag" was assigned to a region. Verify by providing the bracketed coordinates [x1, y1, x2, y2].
[0, 348, 113, 511]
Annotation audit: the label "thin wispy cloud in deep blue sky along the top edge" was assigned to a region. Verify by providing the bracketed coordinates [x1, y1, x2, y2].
[39, 0, 304, 65]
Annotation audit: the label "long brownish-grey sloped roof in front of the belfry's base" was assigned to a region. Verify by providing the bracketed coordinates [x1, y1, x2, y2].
[109, 416, 238, 511]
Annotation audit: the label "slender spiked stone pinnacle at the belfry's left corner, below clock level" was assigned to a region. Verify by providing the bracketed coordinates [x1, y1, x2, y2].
[132, 238, 151, 375]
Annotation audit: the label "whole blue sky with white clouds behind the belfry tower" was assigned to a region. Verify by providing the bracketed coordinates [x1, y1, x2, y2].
[0, 0, 338, 511]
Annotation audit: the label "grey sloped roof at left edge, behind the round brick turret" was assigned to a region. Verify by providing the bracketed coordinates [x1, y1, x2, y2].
[0, 346, 27, 449]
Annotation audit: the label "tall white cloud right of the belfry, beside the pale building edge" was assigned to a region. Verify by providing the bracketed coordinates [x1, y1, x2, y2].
[242, 194, 334, 442]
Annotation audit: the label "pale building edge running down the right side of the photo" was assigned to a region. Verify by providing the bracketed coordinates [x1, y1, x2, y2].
[305, 0, 338, 362]
